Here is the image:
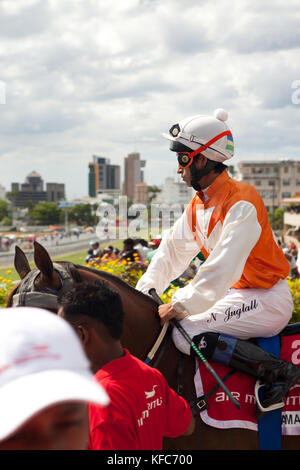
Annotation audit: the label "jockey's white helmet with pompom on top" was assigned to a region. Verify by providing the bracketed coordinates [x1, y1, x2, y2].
[162, 108, 234, 162]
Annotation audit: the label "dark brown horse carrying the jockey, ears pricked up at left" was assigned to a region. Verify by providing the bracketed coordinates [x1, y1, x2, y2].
[6, 242, 300, 451]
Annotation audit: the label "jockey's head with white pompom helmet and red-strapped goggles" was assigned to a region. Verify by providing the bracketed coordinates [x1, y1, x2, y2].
[163, 109, 234, 190]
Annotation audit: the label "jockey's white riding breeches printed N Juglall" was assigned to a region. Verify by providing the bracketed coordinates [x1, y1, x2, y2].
[172, 280, 294, 354]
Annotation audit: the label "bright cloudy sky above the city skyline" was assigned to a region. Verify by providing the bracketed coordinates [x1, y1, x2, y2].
[0, 0, 300, 199]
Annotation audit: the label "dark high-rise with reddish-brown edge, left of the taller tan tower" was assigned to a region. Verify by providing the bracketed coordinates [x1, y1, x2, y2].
[88, 155, 120, 197]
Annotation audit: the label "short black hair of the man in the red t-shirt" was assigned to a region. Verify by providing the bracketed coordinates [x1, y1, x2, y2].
[58, 280, 124, 339]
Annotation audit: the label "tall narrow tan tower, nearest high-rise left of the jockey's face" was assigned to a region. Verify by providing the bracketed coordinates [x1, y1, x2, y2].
[123, 153, 146, 201]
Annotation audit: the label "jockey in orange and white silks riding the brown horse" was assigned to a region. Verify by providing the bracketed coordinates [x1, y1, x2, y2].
[136, 109, 300, 411]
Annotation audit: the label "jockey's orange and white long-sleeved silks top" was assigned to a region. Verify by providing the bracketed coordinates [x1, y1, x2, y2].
[137, 171, 290, 315]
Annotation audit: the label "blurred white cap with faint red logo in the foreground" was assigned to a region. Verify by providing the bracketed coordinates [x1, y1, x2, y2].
[0, 307, 109, 441]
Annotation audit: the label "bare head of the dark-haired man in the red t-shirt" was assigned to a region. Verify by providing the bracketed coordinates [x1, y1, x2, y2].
[58, 280, 124, 372]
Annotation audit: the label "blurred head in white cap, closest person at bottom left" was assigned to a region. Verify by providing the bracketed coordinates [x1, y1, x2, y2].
[0, 307, 109, 450]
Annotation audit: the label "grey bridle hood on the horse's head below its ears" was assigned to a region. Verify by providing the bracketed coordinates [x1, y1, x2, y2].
[12, 263, 75, 310]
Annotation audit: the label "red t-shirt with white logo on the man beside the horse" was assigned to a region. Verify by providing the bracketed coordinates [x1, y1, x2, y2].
[89, 349, 192, 450]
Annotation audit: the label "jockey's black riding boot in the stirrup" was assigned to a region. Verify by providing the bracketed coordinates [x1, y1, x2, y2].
[193, 333, 300, 412]
